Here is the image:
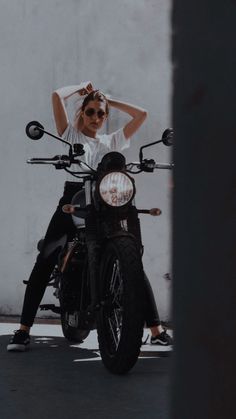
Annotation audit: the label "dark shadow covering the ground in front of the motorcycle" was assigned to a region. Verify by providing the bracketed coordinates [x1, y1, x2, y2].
[0, 335, 171, 419]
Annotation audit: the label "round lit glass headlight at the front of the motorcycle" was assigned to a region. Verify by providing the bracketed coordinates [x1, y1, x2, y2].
[98, 172, 135, 207]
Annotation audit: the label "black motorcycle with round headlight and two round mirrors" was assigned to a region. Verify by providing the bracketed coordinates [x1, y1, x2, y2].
[26, 121, 173, 374]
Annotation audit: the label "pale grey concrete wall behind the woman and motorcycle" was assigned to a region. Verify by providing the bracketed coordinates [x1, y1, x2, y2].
[0, 0, 171, 320]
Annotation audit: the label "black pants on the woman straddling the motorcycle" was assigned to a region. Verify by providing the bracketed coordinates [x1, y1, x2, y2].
[21, 182, 160, 327]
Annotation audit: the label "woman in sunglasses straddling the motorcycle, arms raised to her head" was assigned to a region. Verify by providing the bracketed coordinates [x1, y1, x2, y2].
[7, 82, 171, 351]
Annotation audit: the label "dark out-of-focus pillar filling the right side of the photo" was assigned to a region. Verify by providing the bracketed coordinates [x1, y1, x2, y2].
[171, 0, 236, 419]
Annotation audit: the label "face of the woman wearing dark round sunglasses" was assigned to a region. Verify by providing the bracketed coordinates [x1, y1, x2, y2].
[81, 100, 107, 137]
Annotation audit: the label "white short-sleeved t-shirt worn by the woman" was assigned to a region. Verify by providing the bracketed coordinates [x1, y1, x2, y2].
[62, 123, 130, 181]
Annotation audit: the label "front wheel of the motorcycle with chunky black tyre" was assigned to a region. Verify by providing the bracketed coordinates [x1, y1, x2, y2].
[97, 236, 144, 374]
